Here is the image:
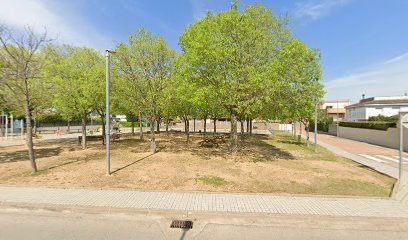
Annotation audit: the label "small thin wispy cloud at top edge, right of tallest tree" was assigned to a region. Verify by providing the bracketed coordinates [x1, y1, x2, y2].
[295, 0, 350, 19]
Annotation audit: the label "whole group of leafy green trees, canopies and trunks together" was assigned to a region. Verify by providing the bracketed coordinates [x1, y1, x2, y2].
[0, 1, 324, 172]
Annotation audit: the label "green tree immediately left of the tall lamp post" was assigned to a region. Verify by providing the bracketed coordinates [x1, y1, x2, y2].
[52, 45, 105, 149]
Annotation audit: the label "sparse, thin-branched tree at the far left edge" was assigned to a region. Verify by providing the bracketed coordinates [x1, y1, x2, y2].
[0, 26, 49, 172]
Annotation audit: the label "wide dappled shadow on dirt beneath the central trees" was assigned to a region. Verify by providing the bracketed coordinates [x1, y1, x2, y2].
[93, 133, 295, 162]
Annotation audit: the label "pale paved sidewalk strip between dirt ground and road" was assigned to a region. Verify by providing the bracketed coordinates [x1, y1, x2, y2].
[0, 186, 408, 218]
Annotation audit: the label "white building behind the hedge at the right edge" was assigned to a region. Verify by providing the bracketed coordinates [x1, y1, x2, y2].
[346, 96, 408, 121]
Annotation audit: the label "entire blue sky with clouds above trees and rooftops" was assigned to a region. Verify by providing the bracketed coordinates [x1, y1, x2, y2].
[0, 0, 408, 101]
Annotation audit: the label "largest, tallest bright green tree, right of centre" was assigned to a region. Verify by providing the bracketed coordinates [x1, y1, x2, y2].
[179, 1, 290, 152]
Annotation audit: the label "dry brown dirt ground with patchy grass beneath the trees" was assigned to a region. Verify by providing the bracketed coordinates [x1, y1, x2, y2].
[0, 133, 394, 197]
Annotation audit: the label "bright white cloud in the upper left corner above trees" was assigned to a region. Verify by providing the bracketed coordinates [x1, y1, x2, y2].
[0, 0, 108, 47]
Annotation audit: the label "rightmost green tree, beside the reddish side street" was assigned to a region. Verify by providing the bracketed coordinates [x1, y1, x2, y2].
[275, 39, 324, 145]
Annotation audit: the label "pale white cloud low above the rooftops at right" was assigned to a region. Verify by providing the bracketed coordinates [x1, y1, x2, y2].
[324, 53, 408, 101]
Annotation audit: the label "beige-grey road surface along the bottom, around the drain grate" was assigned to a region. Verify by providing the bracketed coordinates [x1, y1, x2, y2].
[0, 207, 408, 240]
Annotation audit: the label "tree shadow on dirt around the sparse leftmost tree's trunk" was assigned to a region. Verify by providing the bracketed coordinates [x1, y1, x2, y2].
[0, 147, 62, 164]
